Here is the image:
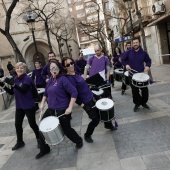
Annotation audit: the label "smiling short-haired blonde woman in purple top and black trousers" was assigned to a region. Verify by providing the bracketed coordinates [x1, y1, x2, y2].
[0, 62, 39, 150]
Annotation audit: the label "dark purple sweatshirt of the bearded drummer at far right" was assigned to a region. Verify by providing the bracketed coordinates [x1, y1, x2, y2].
[122, 47, 151, 72]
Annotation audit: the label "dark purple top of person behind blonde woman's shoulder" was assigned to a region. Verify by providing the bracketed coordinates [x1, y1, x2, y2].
[31, 68, 46, 86]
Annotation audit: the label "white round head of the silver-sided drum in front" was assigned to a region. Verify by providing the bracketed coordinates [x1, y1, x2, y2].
[39, 116, 59, 132]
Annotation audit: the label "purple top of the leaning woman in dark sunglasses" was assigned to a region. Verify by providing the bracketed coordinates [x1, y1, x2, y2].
[67, 74, 93, 104]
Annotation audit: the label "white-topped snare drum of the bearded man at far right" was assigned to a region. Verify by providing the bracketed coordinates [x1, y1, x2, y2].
[132, 73, 150, 88]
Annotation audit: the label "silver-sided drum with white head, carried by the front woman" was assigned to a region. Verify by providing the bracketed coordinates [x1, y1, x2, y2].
[39, 116, 64, 145]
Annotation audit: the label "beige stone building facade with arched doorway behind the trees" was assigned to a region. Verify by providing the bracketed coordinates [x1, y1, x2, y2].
[0, 0, 79, 73]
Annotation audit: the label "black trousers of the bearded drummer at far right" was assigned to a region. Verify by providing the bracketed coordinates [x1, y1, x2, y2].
[129, 76, 149, 106]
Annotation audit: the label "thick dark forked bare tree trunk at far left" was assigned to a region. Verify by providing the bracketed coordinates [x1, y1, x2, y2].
[0, 0, 25, 62]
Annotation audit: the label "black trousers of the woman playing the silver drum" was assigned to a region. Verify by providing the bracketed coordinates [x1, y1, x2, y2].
[39, 108, 82, 153]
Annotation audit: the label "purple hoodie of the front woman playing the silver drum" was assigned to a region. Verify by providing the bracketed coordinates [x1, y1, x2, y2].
[44, 75, 78, 110]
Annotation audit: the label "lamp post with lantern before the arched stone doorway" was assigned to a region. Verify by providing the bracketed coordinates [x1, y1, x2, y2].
[25, 10, 38, 58]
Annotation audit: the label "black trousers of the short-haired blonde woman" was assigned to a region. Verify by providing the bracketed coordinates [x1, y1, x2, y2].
[15, 108, 39, 141]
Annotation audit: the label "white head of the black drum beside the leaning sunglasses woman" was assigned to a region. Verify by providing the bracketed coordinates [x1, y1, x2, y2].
[96, 98, 114, 110]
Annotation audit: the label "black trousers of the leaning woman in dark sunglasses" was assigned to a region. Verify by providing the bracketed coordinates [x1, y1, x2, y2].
[83, 99, 99, 137]
